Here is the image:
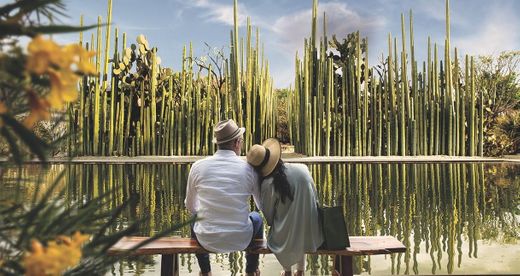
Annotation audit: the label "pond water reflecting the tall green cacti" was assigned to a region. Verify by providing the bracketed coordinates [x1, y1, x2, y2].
[0, 164, 520, 275]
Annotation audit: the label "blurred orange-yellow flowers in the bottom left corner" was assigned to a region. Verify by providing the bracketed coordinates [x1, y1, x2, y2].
[23, 232, 89, 276]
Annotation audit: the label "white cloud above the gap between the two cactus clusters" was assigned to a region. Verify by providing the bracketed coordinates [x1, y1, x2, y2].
[271, 2, 385, 53]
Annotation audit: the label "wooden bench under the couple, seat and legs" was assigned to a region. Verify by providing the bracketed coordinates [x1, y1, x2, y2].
[108, 236, 406, 276]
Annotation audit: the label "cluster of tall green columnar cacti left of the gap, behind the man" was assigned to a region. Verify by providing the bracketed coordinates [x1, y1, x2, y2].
[69, 0, 277, 156]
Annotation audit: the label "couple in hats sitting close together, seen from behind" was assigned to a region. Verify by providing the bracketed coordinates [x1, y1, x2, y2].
[185, 119, 323, 276]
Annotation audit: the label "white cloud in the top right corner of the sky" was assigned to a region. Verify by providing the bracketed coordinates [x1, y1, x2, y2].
[452, 7, 520, 55]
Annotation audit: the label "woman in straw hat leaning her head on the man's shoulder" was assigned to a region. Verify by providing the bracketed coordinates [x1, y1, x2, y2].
[247, 138, 323, 276]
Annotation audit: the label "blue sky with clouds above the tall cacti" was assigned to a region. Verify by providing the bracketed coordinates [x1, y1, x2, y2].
[56, 0, 520, 87]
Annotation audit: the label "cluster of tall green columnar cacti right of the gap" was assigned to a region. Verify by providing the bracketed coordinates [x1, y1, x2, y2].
[287, 0, 483, 156]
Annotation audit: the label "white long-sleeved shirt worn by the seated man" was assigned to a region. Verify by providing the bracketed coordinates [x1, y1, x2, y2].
[184, 150, 261, 253]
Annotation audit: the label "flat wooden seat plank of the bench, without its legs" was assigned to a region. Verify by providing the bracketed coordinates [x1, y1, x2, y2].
[108, 236, 406, 256]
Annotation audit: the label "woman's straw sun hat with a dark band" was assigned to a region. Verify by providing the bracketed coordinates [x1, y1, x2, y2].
[247, 138, 282, 176]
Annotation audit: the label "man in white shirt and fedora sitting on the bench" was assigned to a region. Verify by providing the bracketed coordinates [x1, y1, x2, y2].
[184, 119, 263, 275]
